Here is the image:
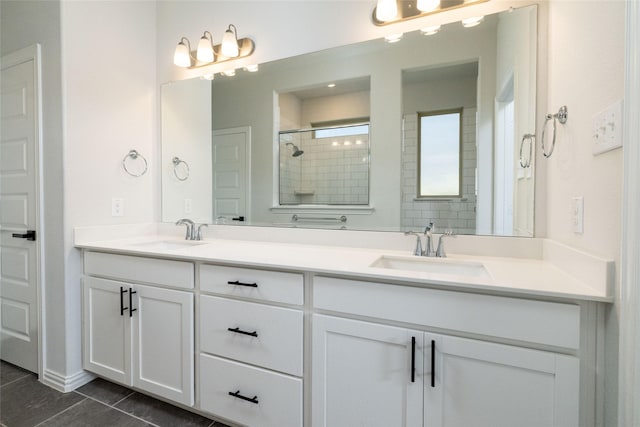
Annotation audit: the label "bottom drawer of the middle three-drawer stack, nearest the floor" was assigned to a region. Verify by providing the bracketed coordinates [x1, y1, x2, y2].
[199, 354, 302, 427]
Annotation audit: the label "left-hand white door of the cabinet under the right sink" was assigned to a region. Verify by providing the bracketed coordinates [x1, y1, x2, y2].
[312, 315, 423, 427]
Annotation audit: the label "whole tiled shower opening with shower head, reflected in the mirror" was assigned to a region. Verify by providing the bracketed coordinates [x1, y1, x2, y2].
[278, 76, 370, 208]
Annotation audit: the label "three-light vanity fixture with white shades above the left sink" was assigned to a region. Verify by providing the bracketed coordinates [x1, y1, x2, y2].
[173, 24, 257, 70]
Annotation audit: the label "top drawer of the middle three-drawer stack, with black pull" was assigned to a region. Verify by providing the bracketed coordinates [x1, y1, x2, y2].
[200, 265, 304, 305]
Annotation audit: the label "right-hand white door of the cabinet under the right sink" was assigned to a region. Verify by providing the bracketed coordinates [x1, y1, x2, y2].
[424, 334, 579, 427]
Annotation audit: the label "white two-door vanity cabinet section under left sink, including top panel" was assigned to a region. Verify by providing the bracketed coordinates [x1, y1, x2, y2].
[83, 252, 194, 405]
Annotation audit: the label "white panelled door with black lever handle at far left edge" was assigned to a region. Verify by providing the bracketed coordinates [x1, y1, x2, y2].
[0, 46, 42, 372]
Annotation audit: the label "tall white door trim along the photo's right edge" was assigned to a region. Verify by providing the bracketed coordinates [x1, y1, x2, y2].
[618, 1, 640, 426]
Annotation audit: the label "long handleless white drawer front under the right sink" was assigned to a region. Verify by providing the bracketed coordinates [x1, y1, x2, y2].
[313, 277, 580, 349]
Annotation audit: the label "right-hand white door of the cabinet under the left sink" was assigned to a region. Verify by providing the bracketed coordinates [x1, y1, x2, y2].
[131, 285, 194, 406]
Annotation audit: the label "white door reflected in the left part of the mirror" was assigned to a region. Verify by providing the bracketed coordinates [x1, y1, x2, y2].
[212, 127, 251, 222]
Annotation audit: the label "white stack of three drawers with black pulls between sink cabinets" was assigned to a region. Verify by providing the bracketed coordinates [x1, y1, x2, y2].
[198, 265, 304, 427]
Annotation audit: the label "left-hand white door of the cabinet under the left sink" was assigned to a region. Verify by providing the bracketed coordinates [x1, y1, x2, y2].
[83, 277, 131, 385]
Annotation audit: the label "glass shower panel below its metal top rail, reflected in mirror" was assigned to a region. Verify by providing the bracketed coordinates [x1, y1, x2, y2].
[279, 122, 369, 206]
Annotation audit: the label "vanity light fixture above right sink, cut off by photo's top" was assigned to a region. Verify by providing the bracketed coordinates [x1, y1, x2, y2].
[371, 0, 489, 25]
